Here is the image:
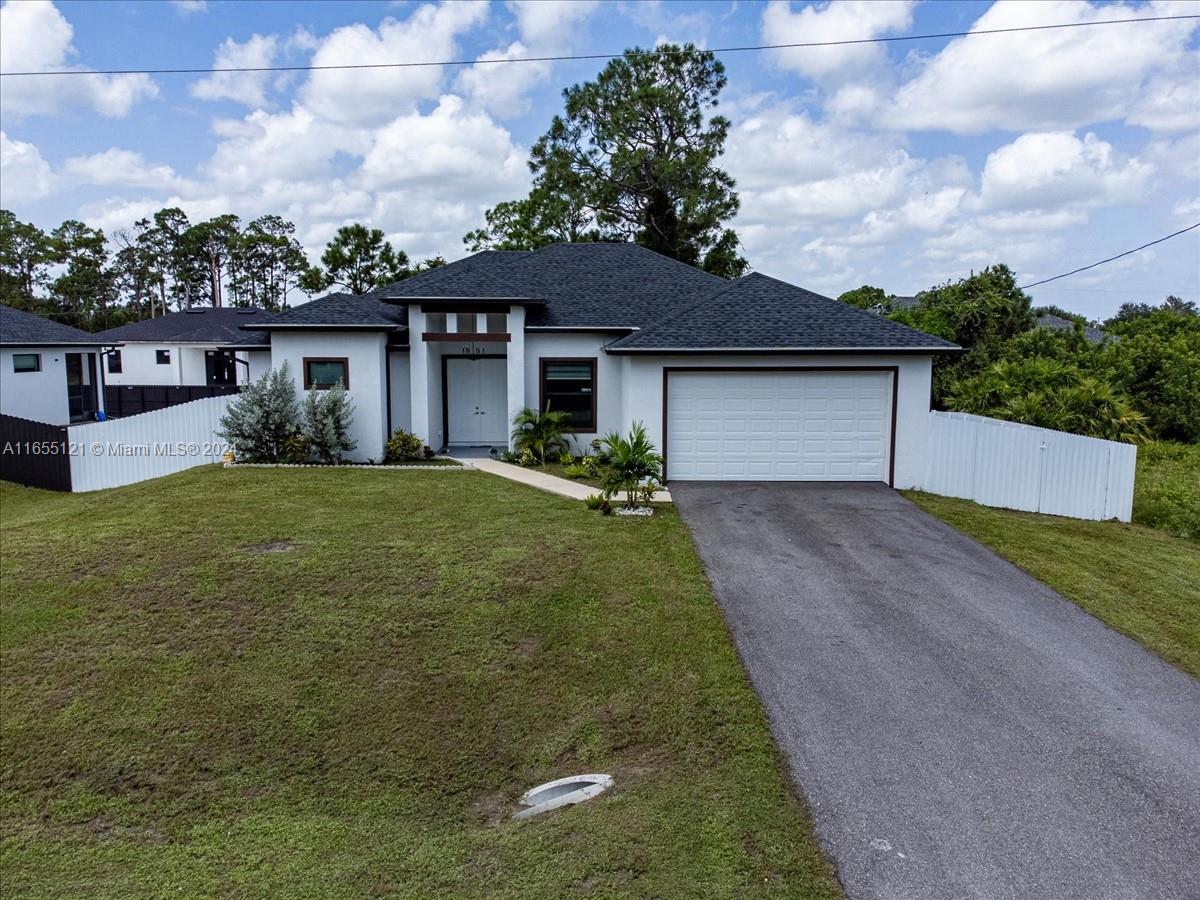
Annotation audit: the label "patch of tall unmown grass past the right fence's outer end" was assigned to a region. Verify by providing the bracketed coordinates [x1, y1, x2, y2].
[1133, 442, 1200, 541]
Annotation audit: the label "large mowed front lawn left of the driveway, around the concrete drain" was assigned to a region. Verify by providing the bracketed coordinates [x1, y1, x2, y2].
[0, 467, 839, 898]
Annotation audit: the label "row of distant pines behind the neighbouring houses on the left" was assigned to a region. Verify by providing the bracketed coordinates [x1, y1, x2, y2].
[0, 206, 444, 331]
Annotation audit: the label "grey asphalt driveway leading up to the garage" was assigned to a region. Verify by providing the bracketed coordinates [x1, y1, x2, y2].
[671, 482, 1200, 900]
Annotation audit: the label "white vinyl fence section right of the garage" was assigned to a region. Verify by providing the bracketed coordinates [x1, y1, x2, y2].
[924, 412, 1138, 522]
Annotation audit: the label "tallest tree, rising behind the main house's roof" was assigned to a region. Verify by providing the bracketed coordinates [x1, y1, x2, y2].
[463, 43, 746, 277]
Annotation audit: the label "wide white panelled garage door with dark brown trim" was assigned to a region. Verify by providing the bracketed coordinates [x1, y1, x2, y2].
[666, 371, 892, 481]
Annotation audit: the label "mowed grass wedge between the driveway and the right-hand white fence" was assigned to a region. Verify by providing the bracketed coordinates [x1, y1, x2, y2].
[906, 492, 1200, 677]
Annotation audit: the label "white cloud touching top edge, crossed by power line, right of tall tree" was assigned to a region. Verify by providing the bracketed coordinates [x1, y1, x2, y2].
[762, 0, 916, 79]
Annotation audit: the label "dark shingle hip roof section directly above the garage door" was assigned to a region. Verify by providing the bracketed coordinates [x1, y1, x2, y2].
[608, 272, 958, 353]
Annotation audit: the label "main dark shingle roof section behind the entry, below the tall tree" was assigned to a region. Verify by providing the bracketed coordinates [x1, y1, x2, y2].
[376, 244, 726, 328]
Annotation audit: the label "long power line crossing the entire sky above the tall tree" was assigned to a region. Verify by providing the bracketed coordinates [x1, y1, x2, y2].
[0, 14, 1200, 78]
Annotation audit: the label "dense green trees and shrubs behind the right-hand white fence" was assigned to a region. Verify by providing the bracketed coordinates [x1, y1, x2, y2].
[838, 273, 1200, 443]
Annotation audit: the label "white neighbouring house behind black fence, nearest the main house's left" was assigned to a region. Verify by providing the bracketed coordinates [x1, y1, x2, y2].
[96, 306, 271, 386]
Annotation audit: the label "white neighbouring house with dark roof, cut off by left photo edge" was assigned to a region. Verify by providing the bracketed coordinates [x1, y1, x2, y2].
[0, 305, 112, 425]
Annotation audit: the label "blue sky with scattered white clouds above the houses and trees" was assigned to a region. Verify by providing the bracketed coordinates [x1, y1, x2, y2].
[0, 0, 1200, 317]
